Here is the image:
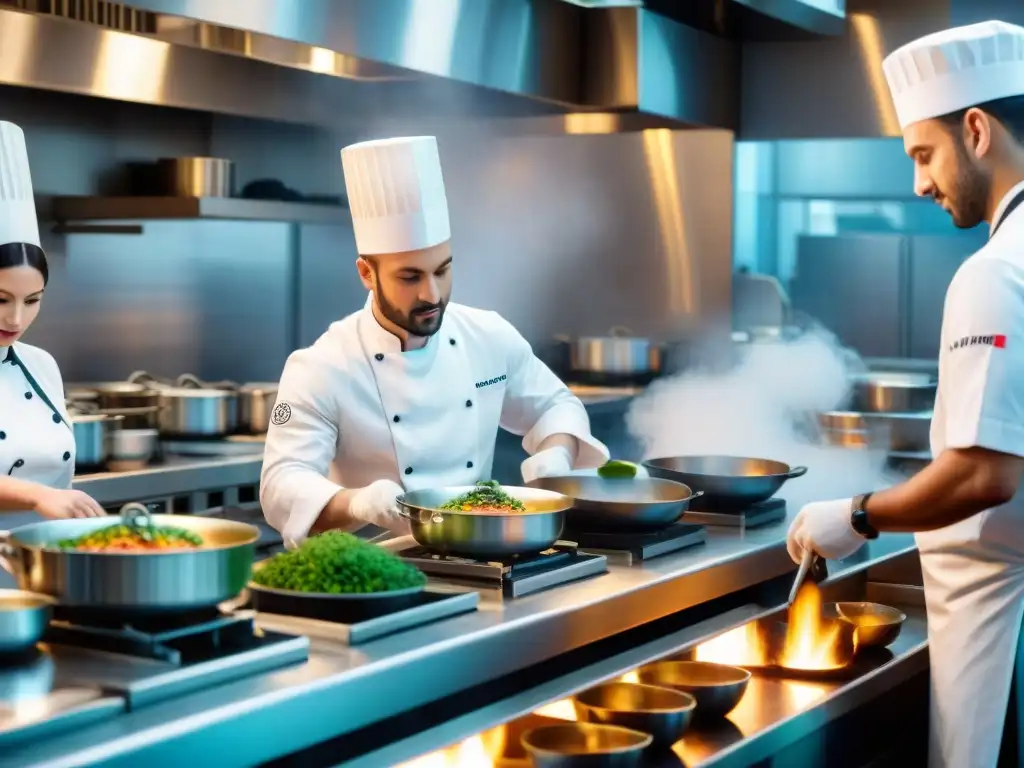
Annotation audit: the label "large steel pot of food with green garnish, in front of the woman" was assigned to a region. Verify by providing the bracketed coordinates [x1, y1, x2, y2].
[0, 504, 259, 612]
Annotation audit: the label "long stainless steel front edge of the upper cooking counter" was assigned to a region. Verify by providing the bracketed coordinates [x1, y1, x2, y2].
[4, 501, 913, 766]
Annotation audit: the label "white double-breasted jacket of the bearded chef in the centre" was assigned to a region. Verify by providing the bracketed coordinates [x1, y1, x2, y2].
[260, 295, 608, 541]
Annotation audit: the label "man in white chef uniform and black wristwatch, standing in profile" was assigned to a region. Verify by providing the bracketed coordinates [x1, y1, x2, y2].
[788, 22, 1024, 768]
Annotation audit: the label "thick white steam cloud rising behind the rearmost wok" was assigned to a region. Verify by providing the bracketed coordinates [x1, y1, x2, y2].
[627, 328, 898, 512]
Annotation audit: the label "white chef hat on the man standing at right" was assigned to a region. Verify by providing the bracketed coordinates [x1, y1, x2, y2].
[882, 22, 1024, 129]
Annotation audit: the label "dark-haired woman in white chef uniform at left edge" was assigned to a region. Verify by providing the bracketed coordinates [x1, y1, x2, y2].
[0, 122, 105, 517]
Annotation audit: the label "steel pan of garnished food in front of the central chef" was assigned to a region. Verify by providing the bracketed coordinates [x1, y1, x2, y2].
[398, 480, 572, 559]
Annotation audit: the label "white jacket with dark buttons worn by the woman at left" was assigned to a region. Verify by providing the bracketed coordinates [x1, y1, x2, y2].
[0, 342, 75, 489]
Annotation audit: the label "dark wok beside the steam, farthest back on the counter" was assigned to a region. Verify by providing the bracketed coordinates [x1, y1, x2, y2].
[643, 456, 807, 509]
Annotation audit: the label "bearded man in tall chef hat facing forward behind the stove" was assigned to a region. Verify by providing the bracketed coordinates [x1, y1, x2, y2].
[260, 136, 608, 543]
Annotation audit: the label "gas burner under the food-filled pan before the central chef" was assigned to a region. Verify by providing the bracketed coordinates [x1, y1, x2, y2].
[398, 545, 608, 597]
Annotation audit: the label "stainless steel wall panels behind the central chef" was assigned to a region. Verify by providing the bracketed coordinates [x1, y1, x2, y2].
[6, 89, 733, 381]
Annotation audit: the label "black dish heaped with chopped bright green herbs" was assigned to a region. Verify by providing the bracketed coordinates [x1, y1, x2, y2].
[249, 530, 427, 623]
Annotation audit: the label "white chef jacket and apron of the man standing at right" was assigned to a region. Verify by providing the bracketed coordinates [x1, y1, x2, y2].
[916, 184, 1024, 768]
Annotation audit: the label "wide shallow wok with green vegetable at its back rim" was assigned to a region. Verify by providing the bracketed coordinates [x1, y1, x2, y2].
[526, 475, 703, 531]
